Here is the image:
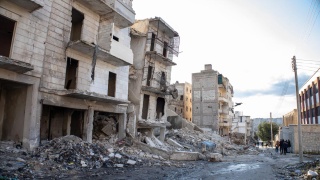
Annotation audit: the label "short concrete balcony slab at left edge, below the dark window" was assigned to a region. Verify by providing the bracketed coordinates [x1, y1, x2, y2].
[0, 56, 33, 74]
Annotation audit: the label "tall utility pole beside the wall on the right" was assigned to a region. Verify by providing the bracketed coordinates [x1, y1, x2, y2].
[292, 56, 302, 163]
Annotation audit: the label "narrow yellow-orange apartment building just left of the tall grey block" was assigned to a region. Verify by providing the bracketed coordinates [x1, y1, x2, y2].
[169, 82, 192, 122]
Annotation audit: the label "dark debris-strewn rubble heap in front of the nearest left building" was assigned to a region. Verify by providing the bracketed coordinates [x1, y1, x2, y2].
[33, 135, 141, 169]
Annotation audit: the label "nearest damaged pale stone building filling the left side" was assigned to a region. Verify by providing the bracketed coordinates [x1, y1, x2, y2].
[0, 0, 135, 149]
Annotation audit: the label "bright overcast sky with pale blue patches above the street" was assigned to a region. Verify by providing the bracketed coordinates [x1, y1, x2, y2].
[133, 0, 320, 118]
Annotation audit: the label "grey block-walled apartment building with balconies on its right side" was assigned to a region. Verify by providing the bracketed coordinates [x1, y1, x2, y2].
[192, 64, 233, 135]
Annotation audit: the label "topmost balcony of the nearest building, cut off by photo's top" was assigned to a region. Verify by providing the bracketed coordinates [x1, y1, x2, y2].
[77, 0, 135, 28]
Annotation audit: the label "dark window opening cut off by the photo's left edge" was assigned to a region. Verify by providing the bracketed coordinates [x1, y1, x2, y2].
[0, 15, 16, 57]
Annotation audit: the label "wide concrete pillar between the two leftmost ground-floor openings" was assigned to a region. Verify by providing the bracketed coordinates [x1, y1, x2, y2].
[22, 79, 41, 150]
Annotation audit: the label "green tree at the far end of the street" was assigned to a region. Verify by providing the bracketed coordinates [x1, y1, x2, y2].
[257, 122, 279, 141]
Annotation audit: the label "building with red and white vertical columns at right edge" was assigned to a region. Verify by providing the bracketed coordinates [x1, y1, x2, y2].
[299, 70, 320, 124]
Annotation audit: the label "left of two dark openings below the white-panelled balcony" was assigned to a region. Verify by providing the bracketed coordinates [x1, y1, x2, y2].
[64, 57, 79, 89]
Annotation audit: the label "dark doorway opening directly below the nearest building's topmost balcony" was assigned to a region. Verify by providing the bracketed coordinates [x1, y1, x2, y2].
[70, 8, 84, 41]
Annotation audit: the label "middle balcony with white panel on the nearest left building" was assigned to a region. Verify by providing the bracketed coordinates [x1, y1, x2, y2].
[67, 40, 133, 66]
